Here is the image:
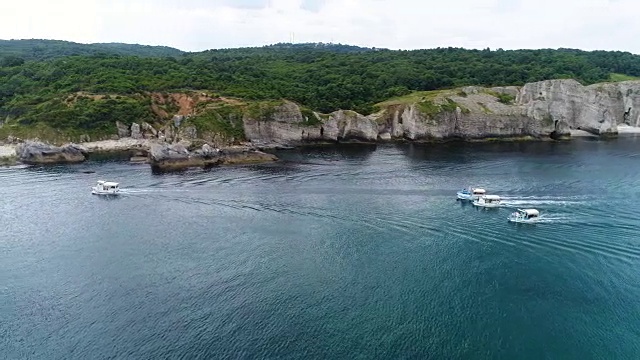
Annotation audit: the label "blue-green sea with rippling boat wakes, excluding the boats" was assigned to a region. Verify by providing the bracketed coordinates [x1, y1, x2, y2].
[0, 137, 640, 359]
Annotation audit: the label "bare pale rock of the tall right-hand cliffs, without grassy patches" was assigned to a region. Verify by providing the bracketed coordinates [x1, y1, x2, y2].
[377, 80, 640, 140]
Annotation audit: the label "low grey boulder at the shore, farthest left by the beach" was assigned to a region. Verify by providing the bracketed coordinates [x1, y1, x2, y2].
[16, 141, 85, 165]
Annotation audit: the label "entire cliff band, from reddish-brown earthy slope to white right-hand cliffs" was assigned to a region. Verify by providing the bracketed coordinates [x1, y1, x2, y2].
[5, 80, 640, 147]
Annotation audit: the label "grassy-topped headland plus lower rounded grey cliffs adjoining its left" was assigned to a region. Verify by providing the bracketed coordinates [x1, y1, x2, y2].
[244, 87, 568, 145]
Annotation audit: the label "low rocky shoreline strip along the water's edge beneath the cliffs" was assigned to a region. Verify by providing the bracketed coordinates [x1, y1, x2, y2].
[0, 126, 640, 172]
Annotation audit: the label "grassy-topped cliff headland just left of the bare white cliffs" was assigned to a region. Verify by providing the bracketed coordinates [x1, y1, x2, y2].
[377, 87, 566, 140]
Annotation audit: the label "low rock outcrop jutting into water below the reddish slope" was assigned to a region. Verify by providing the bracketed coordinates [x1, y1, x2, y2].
[149, 143, 278, 171]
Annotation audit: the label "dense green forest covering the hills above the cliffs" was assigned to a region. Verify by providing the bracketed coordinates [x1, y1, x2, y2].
[0, 40, 640, 135]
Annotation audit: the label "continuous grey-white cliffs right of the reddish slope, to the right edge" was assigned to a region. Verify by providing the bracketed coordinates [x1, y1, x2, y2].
[238, 80, 640, 145]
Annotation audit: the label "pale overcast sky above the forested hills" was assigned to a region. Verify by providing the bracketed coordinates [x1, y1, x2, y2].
[0, 0, 640, 53]
